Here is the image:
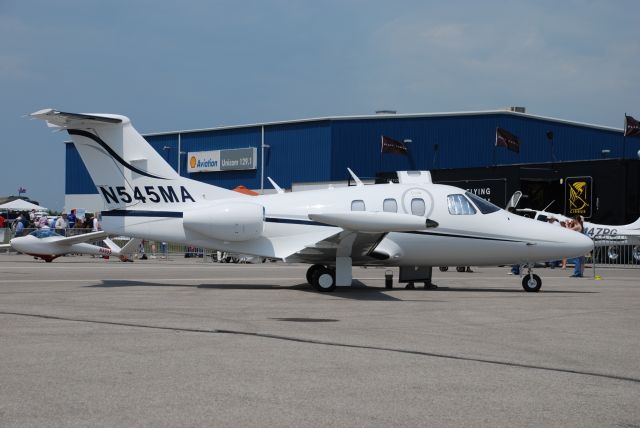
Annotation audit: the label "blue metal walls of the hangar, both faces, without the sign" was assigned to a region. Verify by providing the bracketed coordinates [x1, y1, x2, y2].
[66, 112, 624, 194]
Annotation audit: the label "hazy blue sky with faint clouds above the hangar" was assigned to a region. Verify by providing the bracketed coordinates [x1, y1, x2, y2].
[0, 0, 640, 210]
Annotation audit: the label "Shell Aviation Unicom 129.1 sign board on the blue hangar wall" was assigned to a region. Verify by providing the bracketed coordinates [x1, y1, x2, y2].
[187, 147, 258, 173]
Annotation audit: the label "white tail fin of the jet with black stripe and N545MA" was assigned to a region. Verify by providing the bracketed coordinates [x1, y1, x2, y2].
[31, 109, 244, 210]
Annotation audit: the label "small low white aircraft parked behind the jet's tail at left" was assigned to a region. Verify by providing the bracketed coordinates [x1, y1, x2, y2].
[0, 229, 140, 263]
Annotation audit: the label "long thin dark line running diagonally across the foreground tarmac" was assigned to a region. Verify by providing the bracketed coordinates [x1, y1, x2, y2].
[0, 311, 640, 383]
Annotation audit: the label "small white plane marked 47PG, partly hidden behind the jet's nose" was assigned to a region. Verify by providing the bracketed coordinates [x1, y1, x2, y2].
[516, 208, 640, 261]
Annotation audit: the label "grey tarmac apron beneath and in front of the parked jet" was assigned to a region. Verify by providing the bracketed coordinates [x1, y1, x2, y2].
[0, 254, 640, 428]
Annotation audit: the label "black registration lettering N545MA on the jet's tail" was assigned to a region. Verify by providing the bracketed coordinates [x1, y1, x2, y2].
[98, 186, 195, 204]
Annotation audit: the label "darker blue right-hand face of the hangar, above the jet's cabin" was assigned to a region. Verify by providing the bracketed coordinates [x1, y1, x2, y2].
[332, 114, 622, 179]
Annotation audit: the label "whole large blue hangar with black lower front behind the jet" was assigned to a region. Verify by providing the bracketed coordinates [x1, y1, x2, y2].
[65, 107, 640, 224]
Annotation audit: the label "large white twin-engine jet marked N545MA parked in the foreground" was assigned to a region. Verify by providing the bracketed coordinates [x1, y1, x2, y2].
[31, 109, 593, 291]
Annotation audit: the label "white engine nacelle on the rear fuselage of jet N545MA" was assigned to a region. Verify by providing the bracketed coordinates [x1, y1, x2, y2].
[183, 202, 264, 241]
